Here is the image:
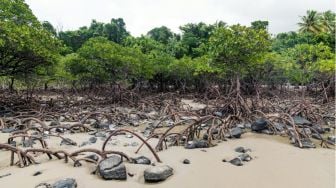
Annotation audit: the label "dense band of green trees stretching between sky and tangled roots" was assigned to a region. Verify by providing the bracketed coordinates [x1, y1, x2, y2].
[0, 0, 335, 101]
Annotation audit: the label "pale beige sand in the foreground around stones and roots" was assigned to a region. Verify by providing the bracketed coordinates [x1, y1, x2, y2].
[0, 133, 335, 188]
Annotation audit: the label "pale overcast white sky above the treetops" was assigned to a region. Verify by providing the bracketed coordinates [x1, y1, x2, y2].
[26, 0, 335, 36]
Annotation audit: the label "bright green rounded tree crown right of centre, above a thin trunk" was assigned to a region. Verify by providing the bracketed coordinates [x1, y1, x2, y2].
[209, 25, 270, 75]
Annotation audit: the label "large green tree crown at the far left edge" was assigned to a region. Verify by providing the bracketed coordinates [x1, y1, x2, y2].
[0, 0, 60, 76]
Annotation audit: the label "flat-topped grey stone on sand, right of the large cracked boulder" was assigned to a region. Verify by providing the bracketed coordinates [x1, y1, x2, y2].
[144, 165, 173, 182]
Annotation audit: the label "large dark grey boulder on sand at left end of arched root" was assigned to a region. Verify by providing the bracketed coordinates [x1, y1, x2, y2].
[97, 155, 127, 180]
